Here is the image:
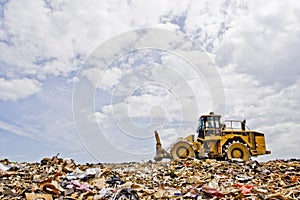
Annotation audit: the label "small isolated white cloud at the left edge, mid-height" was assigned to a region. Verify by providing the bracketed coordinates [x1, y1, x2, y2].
[0, 78, 41, 101]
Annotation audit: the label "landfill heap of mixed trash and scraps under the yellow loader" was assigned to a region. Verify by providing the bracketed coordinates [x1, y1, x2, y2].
[0, 156, 300, 200]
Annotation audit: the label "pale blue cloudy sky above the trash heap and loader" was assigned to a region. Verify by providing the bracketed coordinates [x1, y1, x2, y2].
[0, 0, 300, 162]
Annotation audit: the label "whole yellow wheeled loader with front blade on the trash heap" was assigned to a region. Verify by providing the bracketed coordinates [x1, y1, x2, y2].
[154, 112, 271, 161]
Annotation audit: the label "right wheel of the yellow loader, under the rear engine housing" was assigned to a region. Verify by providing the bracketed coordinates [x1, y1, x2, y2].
[227, 142, 250, 161]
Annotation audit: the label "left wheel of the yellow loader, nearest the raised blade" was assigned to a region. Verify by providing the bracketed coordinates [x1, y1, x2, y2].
[171, 141, 195, 160]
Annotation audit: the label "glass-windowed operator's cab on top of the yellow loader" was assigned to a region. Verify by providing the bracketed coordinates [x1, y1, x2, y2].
[197, 112, 221, 139]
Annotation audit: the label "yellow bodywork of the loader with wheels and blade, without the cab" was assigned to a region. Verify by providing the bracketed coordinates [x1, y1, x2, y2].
[155, 112, 271, 160]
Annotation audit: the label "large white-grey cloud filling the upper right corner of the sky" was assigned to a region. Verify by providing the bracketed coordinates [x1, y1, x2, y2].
[216, 1, 300, 85]
